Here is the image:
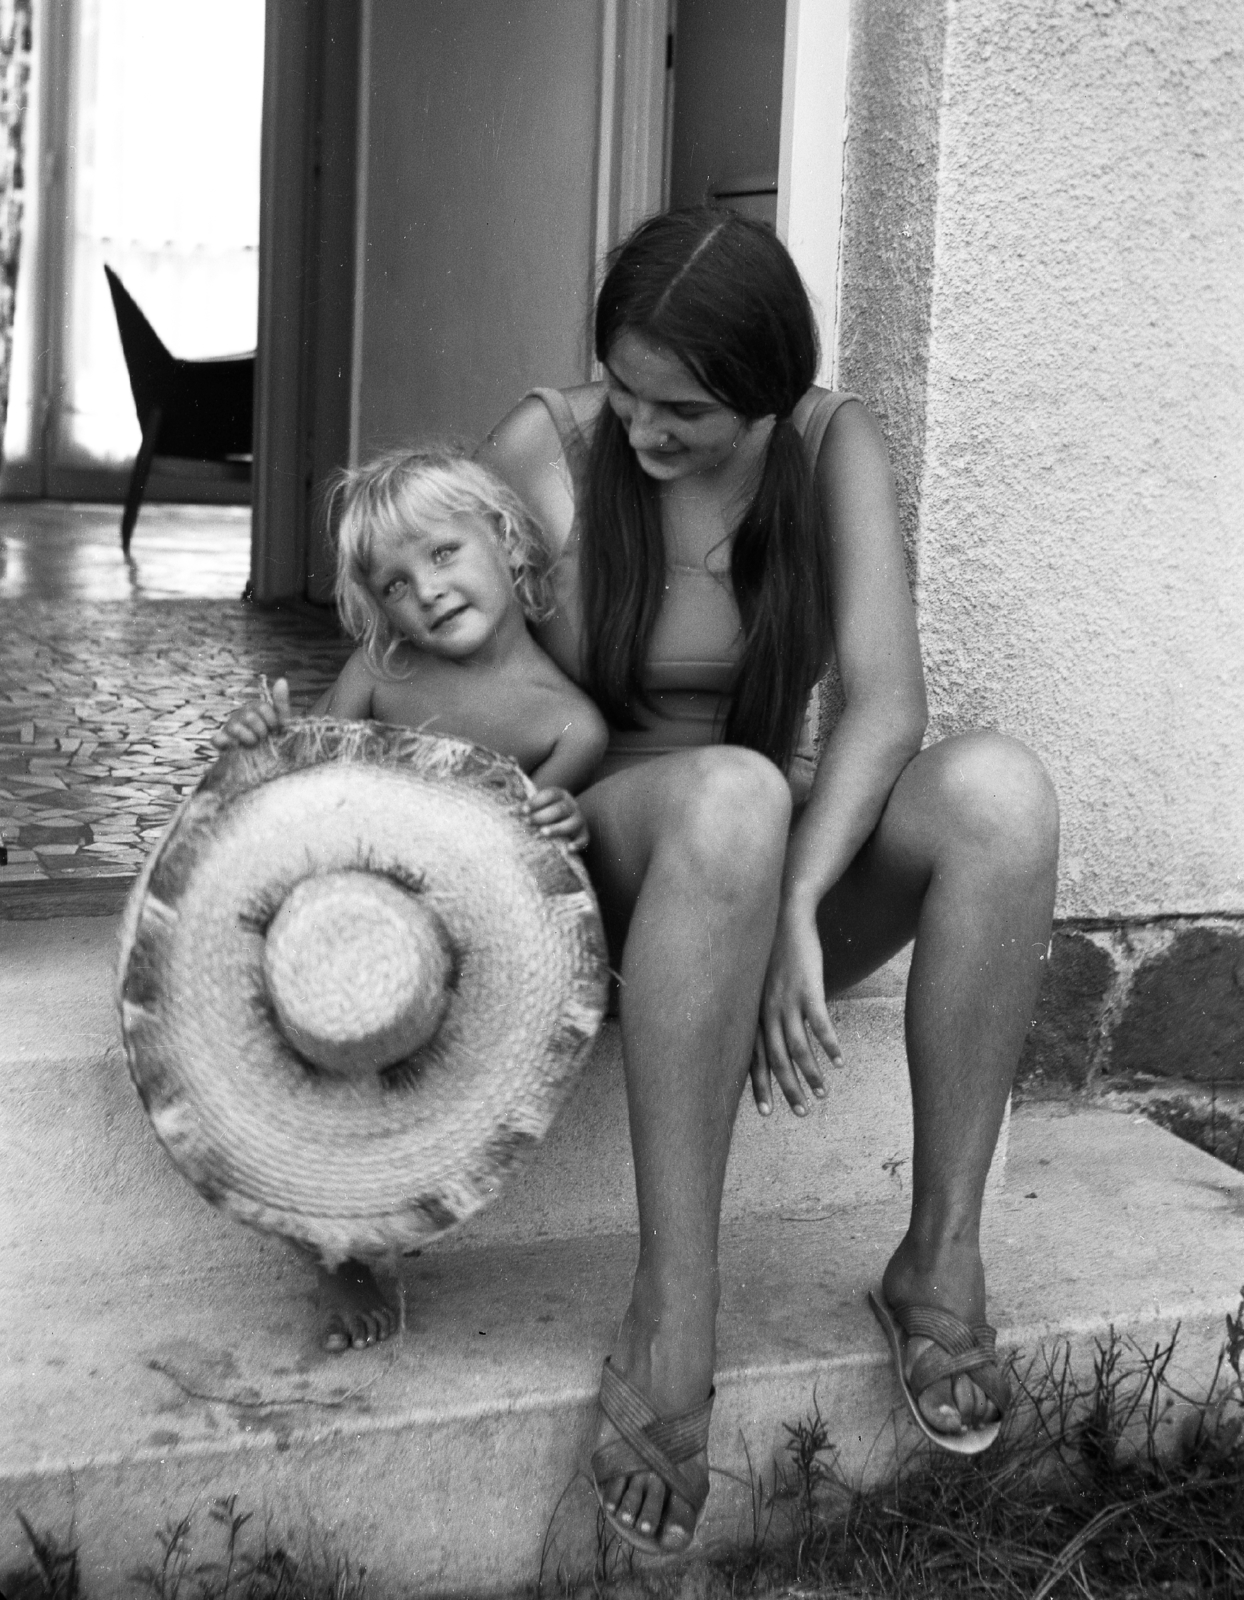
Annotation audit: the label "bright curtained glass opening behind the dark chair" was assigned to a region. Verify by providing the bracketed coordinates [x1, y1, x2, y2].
[0, 0, 264, 502]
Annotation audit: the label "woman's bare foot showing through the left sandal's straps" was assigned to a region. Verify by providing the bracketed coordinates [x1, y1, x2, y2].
[596, 1282, 716, 1555]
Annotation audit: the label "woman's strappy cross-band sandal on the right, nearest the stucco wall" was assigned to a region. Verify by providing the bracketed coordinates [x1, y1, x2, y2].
[868, 1290, 1011, 1456]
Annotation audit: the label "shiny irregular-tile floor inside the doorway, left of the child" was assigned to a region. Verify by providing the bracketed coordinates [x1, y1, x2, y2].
[0, 501, 350, 917]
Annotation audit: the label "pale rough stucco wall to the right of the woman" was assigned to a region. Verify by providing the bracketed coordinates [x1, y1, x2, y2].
[844, 0, 1244, 917]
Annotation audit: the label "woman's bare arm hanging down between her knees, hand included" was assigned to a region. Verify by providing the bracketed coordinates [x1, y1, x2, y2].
[753, 402, 927, 1112]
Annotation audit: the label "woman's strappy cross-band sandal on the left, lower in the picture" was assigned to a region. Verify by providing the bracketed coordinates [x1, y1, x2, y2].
[592, 1357, 716, 1555]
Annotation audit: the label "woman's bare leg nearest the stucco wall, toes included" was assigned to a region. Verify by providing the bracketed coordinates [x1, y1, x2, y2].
[819, 734, 1059, 1432]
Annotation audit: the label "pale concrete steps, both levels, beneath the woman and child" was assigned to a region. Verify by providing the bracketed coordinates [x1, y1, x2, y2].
[0, 918, 1244, 1600]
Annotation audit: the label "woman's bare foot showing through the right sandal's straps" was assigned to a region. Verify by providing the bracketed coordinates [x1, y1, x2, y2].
[881, 1237, 999, 1435]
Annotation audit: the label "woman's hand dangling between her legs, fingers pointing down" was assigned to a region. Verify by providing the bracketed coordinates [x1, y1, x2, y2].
[752, 906, 843, 1117]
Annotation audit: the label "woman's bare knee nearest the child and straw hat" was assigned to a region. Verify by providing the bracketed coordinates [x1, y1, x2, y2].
[665, 746, 790, 886]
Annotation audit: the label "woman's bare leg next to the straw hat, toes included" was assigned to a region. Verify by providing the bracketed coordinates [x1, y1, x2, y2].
[580, 747, 790, 1550]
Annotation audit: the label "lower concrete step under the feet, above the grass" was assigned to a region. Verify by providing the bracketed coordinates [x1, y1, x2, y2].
[0, 1106, 1244, 1600]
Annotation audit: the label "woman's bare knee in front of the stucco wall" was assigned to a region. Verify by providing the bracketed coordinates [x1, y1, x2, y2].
[926, 731, 1059, 867]
